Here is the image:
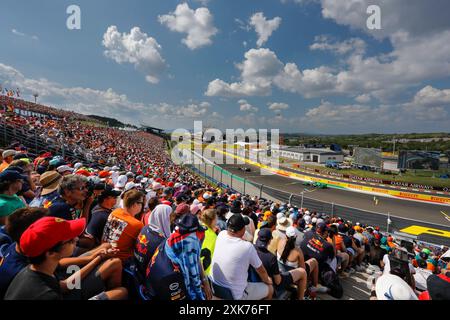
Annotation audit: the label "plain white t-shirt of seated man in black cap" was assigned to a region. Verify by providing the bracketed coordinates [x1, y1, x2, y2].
[211, 231, 262, 300]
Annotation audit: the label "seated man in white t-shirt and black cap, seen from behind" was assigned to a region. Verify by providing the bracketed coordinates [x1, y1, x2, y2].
[211, 214, 273, 300]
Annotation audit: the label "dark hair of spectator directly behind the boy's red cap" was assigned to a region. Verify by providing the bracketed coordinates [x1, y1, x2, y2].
[5, 208, 49, 243]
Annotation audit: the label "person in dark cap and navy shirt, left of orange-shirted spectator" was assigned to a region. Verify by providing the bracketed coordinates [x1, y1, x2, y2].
[86, 186, 120, 248]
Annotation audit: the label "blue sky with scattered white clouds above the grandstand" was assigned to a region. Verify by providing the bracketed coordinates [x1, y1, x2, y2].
[0, 0, 450, 134]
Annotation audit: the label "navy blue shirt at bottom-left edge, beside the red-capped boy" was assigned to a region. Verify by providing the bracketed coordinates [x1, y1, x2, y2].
[0, 242, 28, 300]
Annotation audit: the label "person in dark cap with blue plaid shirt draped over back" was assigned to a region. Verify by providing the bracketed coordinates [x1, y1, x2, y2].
[145, 213, 212, 301]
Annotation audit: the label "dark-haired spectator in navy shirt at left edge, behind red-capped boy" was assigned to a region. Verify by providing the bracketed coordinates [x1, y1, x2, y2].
[0, 208, 48, 299]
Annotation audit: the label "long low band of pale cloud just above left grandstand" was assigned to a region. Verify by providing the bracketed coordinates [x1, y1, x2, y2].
[0, 63, 216, 128]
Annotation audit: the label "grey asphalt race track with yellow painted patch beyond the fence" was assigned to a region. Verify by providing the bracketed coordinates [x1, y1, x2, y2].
[196, 148, 450, 246]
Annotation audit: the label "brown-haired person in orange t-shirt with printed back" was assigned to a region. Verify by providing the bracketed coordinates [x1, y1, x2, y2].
[102, 189, 144, 262]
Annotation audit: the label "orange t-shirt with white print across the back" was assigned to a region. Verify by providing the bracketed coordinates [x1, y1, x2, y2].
[102, 208, 144, 261]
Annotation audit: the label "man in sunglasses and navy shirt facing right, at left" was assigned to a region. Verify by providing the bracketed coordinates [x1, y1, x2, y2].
[46, 175, 89, 220]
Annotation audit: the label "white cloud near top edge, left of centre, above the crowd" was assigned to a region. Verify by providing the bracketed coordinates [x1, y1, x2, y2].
[158, 3, 218, 50]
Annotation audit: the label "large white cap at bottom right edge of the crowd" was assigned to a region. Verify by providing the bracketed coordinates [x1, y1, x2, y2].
[375, 274, 418, 300]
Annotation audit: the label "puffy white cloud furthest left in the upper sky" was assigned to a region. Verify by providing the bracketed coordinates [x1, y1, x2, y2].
[102, 26, 166, 84]
